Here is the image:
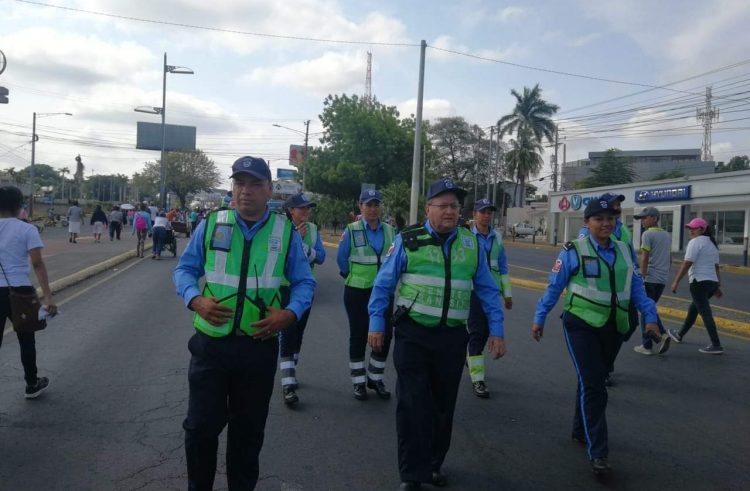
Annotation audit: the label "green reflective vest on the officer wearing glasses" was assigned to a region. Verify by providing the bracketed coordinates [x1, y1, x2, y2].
[396, 227, 480, 327]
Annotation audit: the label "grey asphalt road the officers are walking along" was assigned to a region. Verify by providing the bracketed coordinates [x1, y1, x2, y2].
[0, 248, 750, 491]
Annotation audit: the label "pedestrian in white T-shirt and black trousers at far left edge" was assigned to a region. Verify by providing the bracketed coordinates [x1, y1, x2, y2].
[0, 186, 57, 399]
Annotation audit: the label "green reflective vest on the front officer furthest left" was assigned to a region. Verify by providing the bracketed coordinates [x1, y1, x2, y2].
[193, 210, 292, 337]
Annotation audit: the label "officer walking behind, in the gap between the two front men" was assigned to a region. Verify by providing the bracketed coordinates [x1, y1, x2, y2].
[336, 189, 394, 401]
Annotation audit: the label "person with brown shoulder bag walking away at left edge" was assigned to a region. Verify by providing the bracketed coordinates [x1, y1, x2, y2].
[0, 186, 57, 399]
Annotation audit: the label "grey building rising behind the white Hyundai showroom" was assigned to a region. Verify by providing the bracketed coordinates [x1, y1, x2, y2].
[560, 148, 715, 190]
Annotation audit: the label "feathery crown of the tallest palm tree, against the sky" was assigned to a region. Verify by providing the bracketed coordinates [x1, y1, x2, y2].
[497, 84, 560, 143]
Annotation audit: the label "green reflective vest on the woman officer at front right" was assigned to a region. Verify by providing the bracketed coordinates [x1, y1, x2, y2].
[565, 237, 633, 334]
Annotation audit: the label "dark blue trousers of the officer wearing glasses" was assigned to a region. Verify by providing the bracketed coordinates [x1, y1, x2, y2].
[393, 317, 469, 482]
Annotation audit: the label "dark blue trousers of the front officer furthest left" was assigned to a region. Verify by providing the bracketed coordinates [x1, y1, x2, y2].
[182, 332, 279, 491]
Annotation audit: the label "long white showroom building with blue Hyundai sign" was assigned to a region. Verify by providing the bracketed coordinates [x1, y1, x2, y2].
[548, 171, 750, 254]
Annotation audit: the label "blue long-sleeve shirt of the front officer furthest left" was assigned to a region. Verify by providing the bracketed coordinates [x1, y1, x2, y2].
[172, 209, 315, 319]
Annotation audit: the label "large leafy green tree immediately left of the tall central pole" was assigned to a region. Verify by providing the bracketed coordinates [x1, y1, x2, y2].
[308, 95, 420, 199]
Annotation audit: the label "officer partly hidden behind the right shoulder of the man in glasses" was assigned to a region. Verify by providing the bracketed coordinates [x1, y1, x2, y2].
[466, 198, 513, 399]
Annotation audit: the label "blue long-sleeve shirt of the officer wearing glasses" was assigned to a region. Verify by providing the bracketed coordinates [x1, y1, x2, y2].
[367, 220, 504, 337]
